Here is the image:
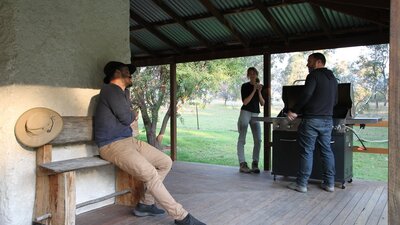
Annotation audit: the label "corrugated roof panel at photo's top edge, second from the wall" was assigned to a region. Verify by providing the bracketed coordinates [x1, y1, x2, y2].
[164, 0, 207, 17]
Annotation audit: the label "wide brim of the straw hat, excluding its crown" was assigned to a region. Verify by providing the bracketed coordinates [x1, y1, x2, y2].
[14, 107, 63, 147]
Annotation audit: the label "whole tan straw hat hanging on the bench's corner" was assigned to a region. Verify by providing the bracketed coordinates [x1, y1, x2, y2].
[15, 107, 63, 147]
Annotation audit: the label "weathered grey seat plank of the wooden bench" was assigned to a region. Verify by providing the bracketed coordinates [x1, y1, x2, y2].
[40, 156, 111, 174]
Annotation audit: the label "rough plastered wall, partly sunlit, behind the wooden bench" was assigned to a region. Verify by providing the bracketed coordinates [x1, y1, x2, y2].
[0, 0, 130, 225]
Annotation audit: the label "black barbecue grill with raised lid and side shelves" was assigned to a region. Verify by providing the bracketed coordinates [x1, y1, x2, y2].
[253, 83, 381, 189]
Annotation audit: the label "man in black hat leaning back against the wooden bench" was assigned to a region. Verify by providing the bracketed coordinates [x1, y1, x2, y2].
[94, 61, 204, 225]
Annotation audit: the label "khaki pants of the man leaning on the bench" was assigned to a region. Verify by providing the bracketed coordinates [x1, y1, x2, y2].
[100, 138, 188, 220]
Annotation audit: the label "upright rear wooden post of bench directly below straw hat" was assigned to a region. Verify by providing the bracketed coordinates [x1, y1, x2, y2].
[33, 145, 52, 225]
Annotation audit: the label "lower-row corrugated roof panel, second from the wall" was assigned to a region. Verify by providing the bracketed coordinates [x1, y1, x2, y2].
[159, 24, 200, 48]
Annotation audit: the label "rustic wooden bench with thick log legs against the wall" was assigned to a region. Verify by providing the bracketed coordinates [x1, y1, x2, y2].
[33, 117, 144, 225]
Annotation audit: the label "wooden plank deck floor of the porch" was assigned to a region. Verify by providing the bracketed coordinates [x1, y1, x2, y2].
[77, 162, 387, 225]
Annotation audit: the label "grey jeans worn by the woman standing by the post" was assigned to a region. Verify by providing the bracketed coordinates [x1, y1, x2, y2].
[237, 110, 261, 163]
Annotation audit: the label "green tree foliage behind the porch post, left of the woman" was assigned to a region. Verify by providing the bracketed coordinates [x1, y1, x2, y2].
[131, 58, 245, 148]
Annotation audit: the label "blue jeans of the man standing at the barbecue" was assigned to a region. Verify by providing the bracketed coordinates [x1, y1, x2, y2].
[297, 119, 335, 186]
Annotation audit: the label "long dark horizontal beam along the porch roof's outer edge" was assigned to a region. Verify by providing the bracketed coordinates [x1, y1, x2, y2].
[133, 29, 389, 66]
